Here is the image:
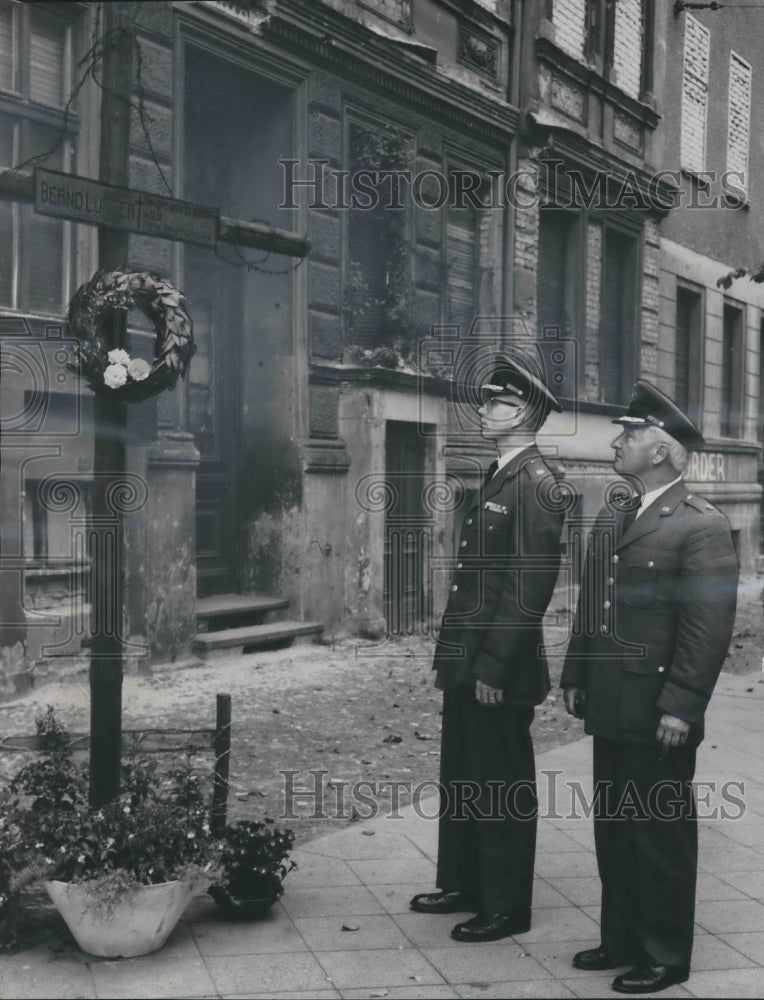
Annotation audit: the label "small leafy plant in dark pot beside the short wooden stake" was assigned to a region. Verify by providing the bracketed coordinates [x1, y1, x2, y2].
[208, 817, 297, 920]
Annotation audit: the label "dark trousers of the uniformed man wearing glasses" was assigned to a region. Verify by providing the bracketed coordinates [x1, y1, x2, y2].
[436, 689, 538, 920]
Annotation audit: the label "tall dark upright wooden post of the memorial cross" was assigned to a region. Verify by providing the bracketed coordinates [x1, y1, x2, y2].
[90, 4, 132, 806]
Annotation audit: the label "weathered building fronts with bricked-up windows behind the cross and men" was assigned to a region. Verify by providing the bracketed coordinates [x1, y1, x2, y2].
[0, 0, 764, 695]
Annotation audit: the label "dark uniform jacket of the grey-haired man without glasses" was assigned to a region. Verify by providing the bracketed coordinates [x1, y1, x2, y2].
[561, 483, 738, 745]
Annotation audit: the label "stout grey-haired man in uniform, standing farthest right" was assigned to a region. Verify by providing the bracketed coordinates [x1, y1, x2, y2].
[561, 381, 738, 993]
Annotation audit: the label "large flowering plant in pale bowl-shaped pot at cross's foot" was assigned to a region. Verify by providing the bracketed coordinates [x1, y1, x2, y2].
[0, 709, 219, 957]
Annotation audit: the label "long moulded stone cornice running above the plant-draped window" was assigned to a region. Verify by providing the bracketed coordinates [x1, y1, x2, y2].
[262, 0, 519, 146]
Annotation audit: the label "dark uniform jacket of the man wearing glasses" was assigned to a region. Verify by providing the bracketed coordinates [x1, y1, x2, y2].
[433, 445, 564, 707]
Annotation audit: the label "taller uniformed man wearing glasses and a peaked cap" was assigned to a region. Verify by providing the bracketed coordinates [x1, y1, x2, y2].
[411, 355, 564, 942]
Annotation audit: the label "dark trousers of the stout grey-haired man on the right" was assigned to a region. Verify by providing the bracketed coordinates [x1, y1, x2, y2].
[594, 737, 698, 968]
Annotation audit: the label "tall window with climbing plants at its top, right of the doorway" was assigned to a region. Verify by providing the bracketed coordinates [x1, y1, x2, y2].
[345, 120, 411, 348]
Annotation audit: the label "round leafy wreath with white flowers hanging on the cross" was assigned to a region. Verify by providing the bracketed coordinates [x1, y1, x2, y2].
[69, 270, 196, 402]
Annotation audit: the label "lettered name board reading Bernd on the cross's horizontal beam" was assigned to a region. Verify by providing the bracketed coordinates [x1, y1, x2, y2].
[34, 167, 218, 246]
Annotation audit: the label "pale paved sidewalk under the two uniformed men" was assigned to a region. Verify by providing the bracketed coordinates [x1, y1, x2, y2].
[0, 674, 764, 1000]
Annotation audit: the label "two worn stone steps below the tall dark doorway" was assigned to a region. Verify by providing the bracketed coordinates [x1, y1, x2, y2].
[193, 594, 324, 662]
